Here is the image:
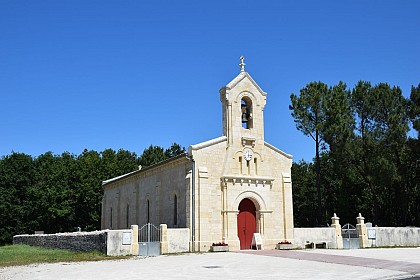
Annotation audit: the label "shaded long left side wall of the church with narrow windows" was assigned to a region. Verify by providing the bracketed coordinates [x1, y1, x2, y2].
[101, 156, 191, 230]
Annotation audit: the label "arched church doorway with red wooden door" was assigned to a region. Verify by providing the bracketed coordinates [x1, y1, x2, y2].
[237, 198, 257, 250]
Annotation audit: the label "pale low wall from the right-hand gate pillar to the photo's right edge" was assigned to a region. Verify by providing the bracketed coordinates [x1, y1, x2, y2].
[367, 227, 420, 247]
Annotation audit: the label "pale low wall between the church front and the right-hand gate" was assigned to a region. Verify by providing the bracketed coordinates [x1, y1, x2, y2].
[293, 228, 341, 249]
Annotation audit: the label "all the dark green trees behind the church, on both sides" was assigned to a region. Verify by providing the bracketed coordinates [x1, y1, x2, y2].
[0, 81, 420, 245]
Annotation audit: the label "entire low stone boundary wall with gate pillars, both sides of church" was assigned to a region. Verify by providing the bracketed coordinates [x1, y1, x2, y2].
[13, 220, 420, 256]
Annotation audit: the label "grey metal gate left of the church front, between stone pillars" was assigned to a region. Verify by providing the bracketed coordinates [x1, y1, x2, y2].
[139, 223, 160, 257]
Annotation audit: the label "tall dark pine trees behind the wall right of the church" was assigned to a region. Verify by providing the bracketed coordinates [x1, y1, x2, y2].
[290, 81, 420, 226]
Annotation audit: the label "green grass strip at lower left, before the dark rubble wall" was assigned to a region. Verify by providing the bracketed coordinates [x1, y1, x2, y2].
[0, 245, 129, 267]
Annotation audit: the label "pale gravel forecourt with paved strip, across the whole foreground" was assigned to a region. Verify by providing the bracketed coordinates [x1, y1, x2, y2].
[0, 248, 420, 280]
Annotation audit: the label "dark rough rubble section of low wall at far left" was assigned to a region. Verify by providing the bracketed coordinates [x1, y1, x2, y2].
[13, 231, 107, 253]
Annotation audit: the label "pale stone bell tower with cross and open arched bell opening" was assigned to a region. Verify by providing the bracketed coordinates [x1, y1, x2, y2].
[219, 56, 267, 149]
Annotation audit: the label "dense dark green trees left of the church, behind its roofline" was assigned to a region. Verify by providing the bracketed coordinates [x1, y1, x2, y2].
[0, 143, 185, 245]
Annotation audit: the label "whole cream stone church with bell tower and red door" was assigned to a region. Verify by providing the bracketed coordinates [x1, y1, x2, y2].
[101, 57, 294, 251]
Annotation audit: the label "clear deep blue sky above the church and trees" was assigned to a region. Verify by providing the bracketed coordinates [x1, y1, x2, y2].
[0, 0, 420, 161]
